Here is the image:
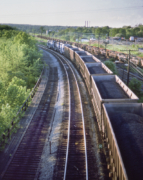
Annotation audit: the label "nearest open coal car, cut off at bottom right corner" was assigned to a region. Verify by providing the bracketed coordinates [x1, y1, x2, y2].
[103, 103, 143, 180]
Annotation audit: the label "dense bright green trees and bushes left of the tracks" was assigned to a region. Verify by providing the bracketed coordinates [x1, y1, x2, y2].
[0, 26, 43, 136]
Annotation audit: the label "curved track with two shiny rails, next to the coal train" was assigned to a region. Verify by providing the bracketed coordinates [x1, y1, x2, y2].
[40, 46, 88, 180]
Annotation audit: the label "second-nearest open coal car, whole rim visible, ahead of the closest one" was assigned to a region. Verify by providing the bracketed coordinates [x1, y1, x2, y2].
[90, 75, 139, 132]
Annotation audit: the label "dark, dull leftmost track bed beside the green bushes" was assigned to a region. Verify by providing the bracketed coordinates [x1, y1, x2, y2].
[1, 64, 58, 180]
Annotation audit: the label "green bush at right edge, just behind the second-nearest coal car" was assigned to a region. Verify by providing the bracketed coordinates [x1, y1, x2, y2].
[129, 78, 142, 97]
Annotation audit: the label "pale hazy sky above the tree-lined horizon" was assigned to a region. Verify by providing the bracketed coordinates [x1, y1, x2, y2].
[0, 0, 143, 27]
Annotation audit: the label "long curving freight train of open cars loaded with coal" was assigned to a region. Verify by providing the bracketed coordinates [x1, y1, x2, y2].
[47, 40, 143, 180]
